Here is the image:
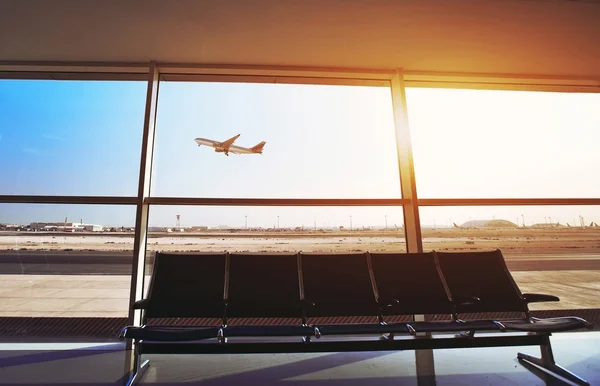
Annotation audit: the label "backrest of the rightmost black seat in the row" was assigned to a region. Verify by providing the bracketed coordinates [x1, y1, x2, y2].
[436, 249, 527, 312]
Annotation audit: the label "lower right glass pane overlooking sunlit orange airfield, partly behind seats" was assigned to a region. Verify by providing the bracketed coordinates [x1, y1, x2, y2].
[420, 206, 600, 310]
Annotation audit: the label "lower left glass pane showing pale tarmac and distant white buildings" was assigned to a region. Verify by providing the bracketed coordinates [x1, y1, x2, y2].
[0, 204, 135, 317]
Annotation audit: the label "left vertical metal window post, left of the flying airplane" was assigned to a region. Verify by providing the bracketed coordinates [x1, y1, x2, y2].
[128, 62, 159, 326]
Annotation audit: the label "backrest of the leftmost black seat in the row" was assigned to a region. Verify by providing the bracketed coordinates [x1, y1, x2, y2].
[145, 252, 226, 318]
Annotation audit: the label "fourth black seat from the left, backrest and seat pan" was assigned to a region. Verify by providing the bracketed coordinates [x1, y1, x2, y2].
[370, 252, 498, 333]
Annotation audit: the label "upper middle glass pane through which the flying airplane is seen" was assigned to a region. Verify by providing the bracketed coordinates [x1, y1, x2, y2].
[152, 82, 400, 201]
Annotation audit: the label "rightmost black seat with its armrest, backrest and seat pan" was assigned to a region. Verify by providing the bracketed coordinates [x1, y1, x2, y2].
[436, 249, 592, 332]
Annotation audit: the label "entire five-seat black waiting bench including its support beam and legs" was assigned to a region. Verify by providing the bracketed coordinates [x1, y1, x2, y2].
[120, 250, 592, 385]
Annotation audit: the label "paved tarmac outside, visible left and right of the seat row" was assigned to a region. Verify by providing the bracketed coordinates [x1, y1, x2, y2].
[0, 251, 600, 317]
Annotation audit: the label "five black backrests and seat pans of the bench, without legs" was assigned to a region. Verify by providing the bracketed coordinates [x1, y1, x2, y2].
[125, 250, 590, 340]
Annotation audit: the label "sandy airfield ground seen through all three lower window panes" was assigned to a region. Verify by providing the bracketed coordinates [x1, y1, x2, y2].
[0, 228, 600, 317]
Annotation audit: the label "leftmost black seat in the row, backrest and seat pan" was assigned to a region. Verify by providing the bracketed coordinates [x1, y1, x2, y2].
[121, 252, 226, 341]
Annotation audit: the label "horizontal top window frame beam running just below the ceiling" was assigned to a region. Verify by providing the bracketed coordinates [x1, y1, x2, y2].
[0, 60, 600, 93]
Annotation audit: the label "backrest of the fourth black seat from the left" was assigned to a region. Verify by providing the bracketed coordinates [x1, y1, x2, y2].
[370, 252, 452, 315]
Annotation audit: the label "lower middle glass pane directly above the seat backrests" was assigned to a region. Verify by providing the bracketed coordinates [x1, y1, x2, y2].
[145, 205, 406, 294]
